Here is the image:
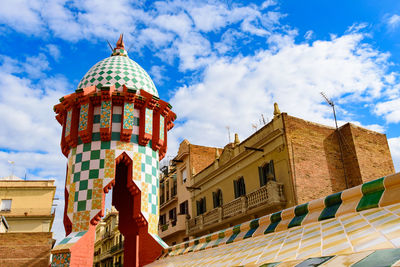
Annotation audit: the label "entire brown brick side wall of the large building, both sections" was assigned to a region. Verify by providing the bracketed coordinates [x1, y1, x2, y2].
[282, 113, 394, 204]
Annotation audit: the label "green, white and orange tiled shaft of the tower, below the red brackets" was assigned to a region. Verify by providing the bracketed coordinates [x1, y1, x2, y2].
[66, 106, 159, 235]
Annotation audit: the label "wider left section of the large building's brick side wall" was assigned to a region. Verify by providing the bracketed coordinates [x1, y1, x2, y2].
[282, 113, 346, 204]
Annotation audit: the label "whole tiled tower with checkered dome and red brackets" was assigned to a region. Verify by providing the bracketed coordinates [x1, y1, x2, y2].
[52, 35, 176, 266]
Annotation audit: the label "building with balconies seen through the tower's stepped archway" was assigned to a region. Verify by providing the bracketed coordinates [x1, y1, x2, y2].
[93, 207, 124, 267]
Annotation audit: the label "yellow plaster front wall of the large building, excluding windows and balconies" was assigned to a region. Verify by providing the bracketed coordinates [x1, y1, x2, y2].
[191, 116, 295, 228]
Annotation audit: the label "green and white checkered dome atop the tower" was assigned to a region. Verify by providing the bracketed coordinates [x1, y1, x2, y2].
[78, 49, 158, 96]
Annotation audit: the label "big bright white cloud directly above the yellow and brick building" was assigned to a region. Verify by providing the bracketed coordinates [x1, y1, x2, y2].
[169, 30, 400, 153]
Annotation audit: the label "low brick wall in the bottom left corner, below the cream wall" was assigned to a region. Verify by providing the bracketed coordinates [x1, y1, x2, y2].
[0, 233, 53, 267]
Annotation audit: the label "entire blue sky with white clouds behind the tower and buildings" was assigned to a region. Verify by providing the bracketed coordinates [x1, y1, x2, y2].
[0, 0, 400, 243]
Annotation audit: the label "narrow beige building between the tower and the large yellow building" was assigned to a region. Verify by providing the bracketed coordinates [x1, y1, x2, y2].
[158, 139, 221, 245]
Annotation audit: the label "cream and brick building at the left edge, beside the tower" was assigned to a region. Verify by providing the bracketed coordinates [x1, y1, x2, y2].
[0, 176, 56, 266]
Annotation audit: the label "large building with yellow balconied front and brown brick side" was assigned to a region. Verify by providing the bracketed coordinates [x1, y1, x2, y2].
[187, 105, 394, 237]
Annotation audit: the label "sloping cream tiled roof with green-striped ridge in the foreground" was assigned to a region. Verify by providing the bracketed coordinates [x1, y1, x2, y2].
[148, 173, 400, 266]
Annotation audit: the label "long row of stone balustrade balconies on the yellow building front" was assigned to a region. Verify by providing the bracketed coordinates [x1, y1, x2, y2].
[186, 181, 286, 235]
